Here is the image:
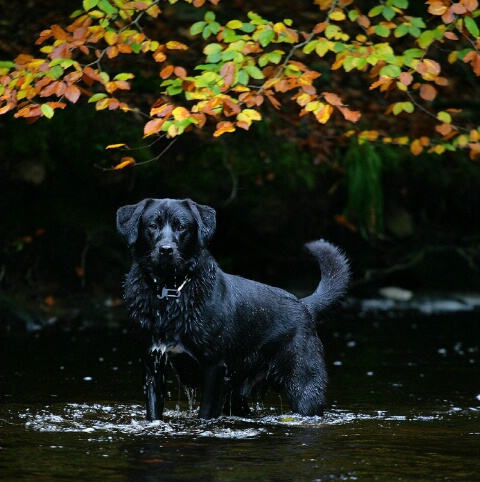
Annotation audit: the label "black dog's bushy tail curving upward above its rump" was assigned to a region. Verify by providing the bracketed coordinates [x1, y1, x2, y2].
[301, 239, 350, 321]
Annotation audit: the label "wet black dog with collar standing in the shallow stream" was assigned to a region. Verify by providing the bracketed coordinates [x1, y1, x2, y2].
[117, 199, 349, 420]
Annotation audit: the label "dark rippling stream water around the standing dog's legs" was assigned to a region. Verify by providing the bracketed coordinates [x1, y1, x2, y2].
[0, 313, 480, 482]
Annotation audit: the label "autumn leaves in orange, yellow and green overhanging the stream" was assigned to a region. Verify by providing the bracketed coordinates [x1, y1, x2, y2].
[0, 0, 480, 169]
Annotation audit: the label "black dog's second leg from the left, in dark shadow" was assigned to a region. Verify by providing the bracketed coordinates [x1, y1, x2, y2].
[198, 365, 227, 419]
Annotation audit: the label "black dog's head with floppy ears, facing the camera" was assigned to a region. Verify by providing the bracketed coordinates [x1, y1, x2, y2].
[117, 199, 216, 275]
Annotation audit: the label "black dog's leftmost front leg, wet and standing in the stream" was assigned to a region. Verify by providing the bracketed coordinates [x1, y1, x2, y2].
[143, 352, 166, 421]
